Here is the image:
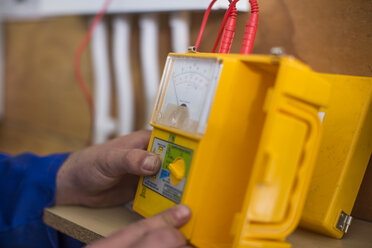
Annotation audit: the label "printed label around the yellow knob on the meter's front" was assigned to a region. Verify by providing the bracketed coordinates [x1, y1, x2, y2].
[143, 138, 193, 203]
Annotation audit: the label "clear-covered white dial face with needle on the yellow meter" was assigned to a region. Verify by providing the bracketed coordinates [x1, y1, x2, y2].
[152, 56, 222, 134]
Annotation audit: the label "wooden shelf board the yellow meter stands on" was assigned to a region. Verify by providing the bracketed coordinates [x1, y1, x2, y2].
[44, 206, 372, 248]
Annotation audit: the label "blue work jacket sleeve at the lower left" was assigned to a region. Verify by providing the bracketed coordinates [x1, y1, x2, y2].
[0, 153, 82, 248]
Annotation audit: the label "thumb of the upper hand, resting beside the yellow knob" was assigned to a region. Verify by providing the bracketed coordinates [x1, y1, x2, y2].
[98, 149, 161, 177]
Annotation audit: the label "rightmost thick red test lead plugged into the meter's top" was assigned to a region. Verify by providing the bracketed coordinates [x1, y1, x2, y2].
[240, 0, 258, 54]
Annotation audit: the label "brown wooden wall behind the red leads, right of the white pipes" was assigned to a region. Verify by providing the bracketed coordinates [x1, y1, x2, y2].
[199, 0, 372, 76]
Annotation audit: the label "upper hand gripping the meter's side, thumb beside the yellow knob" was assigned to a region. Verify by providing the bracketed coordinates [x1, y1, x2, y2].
[56, 131, 160, 207]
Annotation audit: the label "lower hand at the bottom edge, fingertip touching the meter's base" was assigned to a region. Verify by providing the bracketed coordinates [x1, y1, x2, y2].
[87, 205, 191, 248]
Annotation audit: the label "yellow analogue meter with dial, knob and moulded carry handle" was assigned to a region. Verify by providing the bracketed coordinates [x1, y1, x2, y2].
[133, 53, 330, 248]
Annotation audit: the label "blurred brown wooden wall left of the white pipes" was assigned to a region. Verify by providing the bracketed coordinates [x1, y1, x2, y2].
[0, 17, 91, 154]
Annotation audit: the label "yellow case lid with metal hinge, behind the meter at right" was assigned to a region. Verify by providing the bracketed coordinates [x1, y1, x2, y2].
[300, 74, 372, 238]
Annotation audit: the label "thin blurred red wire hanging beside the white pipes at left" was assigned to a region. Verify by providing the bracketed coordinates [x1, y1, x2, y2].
[74, 0, 112, 124]
